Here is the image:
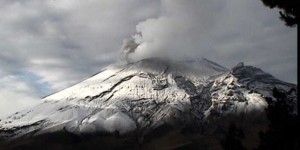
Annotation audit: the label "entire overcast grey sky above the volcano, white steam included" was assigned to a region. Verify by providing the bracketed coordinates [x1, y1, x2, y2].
[0, 0, 297, 117]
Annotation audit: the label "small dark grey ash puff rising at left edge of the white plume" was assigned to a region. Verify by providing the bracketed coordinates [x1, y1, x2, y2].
[120, 38, 139, 62]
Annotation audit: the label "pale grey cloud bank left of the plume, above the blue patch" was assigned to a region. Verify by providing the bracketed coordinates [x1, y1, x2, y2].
[0, 0, 159, 90]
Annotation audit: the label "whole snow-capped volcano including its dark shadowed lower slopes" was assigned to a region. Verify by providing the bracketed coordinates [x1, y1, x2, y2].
[0, 58, 297, 149]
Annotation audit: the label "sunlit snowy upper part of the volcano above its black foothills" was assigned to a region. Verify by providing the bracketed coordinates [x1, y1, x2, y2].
[0, 58, 297, 149]
